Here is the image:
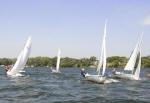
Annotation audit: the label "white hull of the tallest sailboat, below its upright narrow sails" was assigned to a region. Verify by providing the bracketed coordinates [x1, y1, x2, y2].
[85, 75, 105, 84]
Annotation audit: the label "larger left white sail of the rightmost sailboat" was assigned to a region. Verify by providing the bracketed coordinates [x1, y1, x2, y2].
[124, 33, 143, 73]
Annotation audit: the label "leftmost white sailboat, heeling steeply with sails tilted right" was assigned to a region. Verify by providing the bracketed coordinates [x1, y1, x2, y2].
[7, 36, 32, 77]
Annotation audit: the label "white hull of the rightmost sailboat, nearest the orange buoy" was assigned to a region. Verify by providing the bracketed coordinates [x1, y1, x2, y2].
[113, 74, 140, 80]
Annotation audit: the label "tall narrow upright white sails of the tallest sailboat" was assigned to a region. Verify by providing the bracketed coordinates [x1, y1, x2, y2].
[97, 21, 107, 76]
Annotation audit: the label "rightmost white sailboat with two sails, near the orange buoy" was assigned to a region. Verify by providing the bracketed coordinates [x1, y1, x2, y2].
[114, 33, 143, 80]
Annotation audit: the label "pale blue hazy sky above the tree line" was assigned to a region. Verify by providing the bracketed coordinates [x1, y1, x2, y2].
[0, 0, 150, 58]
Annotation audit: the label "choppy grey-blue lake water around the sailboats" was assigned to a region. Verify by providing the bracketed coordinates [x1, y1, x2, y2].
[0, 68, 150, 103]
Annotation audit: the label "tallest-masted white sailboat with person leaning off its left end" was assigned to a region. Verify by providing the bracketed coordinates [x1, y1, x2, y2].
[85, 21, 107, 83]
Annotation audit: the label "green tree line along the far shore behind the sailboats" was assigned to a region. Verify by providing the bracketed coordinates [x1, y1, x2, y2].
[0, 56, 150, 68]
